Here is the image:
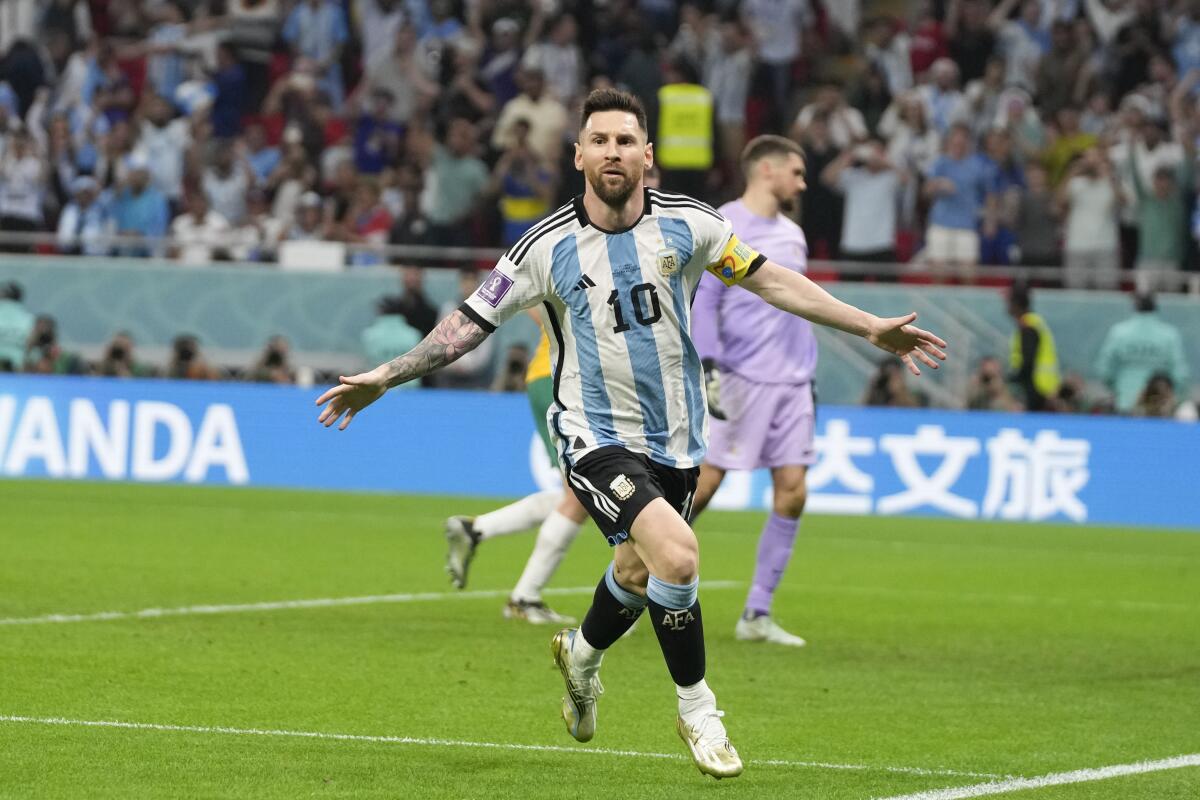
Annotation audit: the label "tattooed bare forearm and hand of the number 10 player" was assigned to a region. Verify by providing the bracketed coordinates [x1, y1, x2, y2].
[317, 311, 488, 431]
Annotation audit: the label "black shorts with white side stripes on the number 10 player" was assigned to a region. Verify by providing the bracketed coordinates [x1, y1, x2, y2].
[566, 446, 700, 547]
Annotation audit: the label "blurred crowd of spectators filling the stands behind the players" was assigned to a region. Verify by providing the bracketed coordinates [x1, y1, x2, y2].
[0, 0, 1200, 419]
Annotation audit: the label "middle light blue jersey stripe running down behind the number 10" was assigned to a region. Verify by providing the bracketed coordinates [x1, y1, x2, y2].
[605, 231, 676, 467]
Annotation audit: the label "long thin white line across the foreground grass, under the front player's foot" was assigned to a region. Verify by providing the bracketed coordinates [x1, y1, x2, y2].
[0, 715, 1001, 777]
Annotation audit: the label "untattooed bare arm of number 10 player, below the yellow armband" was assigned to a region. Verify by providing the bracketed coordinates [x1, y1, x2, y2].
[740, 260, 946, 375]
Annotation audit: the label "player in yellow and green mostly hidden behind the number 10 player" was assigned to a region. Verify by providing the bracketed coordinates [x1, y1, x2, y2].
[445, 319, 588, 625]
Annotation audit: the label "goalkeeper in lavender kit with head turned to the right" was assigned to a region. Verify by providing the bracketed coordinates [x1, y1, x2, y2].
[692, 136, 817, 646]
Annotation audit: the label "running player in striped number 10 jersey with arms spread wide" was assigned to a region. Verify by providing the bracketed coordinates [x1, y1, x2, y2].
[317, 89, 946, 777]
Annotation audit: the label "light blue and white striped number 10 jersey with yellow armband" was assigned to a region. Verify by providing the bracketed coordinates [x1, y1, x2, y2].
[461, 190, 766, 469]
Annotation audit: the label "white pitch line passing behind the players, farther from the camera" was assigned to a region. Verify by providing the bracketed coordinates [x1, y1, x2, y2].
[0, 581, 744, 627]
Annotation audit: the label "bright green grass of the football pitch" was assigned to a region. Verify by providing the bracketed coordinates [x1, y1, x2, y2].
[0, 481, 1200, 800]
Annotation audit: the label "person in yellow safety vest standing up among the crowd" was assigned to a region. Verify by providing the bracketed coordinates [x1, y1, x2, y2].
[654, 64, 714, 197]
